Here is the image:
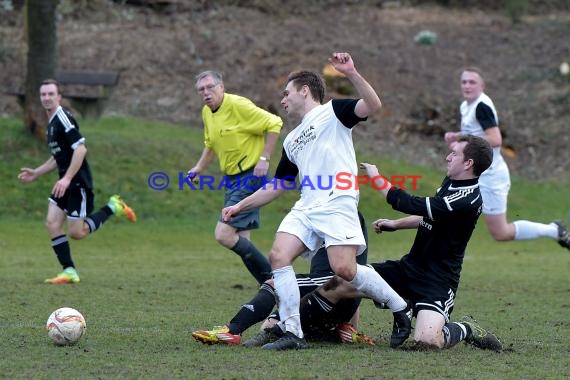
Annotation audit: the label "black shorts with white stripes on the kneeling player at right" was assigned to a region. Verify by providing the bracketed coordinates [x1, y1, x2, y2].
[368, 260, 455, 322]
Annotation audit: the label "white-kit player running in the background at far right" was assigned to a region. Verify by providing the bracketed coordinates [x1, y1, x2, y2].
[445, 67, 570, 249]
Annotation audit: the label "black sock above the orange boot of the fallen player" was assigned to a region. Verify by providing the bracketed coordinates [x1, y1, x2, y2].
[228, 283, 276, 334]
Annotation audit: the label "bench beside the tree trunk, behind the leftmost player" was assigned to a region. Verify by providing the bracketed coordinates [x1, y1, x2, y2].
[7, 71, 119, 119]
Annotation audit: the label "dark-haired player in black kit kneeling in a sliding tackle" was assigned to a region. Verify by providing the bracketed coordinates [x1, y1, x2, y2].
[300, 135, 502, 351]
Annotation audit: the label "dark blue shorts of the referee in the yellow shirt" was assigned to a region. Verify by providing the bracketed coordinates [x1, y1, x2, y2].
[219, 169, 263, 231]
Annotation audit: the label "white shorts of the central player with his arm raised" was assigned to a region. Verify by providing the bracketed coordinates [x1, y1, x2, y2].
[277, 196, 366, 260]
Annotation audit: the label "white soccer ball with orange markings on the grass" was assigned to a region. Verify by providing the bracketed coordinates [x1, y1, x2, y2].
[46, 307, 87, 346]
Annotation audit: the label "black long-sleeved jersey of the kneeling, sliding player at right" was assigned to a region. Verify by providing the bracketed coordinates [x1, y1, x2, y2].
[387, 177, 483, 292]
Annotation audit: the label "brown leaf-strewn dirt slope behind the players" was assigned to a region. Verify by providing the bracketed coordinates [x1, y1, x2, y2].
[0, 0, 570, 179]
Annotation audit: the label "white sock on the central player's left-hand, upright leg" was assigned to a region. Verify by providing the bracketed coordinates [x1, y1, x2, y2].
[273, 265, 303, 338]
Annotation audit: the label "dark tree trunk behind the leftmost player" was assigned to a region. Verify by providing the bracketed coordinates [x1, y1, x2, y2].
[24, 0, 59, 141]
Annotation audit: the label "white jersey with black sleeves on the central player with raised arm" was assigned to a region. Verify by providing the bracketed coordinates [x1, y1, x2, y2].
[283, 101, 363, 209]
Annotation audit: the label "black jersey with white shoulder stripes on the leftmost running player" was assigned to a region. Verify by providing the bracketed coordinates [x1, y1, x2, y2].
[47, 106, 93, 189]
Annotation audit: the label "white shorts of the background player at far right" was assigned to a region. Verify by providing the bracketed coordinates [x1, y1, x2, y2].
[479, 160, 511, 215]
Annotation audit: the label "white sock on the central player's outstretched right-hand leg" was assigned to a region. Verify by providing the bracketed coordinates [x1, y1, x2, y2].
[351, 265, 407, 312]
